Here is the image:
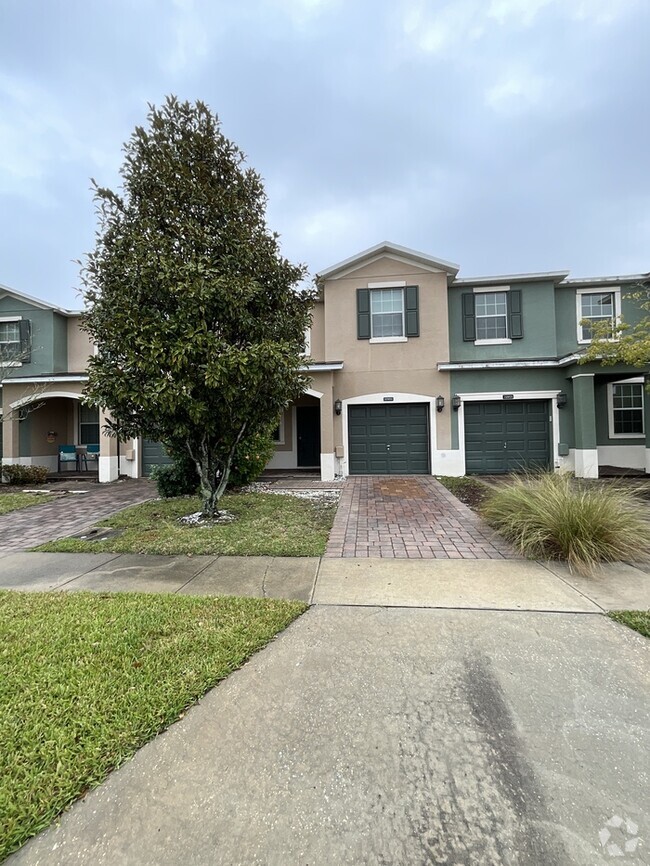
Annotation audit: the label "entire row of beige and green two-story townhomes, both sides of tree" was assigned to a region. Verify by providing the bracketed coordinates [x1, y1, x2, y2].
[0, 243, 650, 481]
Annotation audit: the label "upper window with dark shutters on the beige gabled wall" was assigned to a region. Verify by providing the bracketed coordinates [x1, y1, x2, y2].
[357, 283, 420, 343]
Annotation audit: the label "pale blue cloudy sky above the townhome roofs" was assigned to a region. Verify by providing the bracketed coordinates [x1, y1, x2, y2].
[0, 0, 650, 308]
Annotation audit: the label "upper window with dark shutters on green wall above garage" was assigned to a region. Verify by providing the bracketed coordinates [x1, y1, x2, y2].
[462, 286, 524, 346]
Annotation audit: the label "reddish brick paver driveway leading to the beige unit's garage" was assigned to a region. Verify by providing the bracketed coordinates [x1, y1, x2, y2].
[325, 475, 517, 559]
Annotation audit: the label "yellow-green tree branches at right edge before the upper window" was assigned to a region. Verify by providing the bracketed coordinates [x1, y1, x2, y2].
[578, 279, 650, 367]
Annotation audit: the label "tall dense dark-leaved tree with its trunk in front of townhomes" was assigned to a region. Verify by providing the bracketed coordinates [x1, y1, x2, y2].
[81, 97, 313, 515]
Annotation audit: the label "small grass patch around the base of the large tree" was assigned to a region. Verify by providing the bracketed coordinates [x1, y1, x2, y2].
[36, 493, 336, 556]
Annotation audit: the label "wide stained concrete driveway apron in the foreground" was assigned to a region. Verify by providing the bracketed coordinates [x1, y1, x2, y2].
[7, 608, 650, 866]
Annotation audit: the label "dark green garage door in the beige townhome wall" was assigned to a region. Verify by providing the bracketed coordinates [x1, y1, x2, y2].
[348, 403, 429, 475]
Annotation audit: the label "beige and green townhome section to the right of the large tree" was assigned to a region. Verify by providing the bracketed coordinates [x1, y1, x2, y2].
[270, 243, 650, 479]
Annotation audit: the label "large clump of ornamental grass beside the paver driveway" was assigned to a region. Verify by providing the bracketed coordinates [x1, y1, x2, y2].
[481, 473, 650, 574]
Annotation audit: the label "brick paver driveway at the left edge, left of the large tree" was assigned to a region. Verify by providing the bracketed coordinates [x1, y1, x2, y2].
[0, 478, 157, 554]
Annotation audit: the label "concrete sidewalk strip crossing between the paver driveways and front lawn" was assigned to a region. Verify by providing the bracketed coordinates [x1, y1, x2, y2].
[0, 553, 650, 613]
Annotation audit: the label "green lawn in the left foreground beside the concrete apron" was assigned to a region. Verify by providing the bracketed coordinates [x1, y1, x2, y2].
[0, 592, 306, 860]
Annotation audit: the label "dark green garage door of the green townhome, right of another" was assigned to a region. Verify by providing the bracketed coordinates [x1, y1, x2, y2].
[465, 400, 551, 475]
